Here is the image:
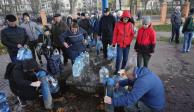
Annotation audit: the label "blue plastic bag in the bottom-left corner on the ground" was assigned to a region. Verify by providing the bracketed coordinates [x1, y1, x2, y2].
[0, 92, 11, 112]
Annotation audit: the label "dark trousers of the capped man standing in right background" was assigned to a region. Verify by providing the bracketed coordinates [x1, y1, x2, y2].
[170, 26, 180, 44]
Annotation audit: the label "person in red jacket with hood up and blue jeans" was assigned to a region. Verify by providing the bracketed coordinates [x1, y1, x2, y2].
[112, 10, 134, 74]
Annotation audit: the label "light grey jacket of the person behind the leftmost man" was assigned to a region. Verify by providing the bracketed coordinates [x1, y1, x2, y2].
[20, 21, 42, 41]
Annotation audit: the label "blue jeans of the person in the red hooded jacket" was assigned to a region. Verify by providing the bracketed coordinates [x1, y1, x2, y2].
[116, 46, 130, 72]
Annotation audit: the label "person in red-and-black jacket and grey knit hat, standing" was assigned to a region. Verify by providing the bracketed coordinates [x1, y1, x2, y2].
[135, 17, 156, 67]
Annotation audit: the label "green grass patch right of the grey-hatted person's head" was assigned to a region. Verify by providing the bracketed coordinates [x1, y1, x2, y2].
[153, 24, 171, 32]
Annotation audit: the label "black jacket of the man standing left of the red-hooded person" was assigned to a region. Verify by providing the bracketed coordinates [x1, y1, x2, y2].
[98, 14, 116, 42]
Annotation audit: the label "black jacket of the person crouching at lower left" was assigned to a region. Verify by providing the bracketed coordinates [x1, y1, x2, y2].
[9, 61, 38, 100]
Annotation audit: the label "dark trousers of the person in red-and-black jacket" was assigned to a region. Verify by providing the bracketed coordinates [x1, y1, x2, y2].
[137, 53, 151, 67]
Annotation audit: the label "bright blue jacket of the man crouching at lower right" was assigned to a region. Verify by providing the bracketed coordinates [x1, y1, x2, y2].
[113, 67, 165, 111]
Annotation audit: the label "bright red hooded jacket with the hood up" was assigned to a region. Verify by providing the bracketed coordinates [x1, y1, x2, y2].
[112, 11, 134, 48]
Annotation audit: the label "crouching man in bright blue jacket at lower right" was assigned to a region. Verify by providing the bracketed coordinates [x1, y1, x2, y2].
[104, 67, 165, 112]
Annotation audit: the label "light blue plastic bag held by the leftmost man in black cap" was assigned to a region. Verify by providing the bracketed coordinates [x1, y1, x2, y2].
[17, 48, 33, 61]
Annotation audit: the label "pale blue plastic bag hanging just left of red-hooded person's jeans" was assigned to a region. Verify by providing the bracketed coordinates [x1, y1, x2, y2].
[107, 45, 117, 60]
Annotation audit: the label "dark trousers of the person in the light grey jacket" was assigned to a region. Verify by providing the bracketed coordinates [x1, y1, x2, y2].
[29, 40, 42, 62]
